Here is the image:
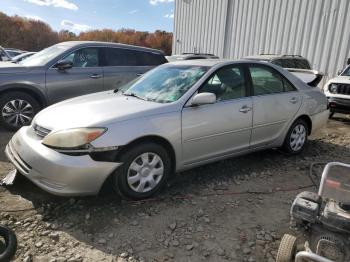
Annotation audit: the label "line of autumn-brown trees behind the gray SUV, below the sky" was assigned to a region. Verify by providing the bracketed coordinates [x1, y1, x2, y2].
[0, 12, 173, 55]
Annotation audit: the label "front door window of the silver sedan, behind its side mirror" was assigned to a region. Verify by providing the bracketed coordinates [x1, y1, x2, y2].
[199, 66, 246, 101]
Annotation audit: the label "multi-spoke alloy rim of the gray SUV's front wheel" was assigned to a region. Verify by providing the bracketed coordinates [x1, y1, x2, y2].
[1, 99, 34, 127]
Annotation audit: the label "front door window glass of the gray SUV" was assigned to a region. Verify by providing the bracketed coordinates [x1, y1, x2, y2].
[65, 47, 99, 67]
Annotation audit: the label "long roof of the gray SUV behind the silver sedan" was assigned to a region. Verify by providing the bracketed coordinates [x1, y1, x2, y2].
[59, 41, 164, 54]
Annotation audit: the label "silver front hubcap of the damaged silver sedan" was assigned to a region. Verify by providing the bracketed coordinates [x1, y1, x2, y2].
[127, 152, 164, 193]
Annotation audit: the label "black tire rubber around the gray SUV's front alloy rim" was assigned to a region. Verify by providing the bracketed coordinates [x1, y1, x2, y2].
[0, 91, 40, 131]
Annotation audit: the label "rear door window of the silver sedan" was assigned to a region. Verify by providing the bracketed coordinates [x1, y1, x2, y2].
[249, 66, 284, 95]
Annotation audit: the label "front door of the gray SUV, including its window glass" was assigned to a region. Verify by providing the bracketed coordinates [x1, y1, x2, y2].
[46, 47, 103, 104]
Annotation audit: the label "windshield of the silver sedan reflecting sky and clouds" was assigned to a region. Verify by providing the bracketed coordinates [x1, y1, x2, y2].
[123, 65, 208, 103]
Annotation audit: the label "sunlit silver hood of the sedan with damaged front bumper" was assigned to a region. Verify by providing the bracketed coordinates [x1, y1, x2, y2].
[34, 91, 174, 130]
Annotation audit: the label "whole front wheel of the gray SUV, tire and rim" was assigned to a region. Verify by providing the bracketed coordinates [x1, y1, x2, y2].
[0, 92, 40, 131]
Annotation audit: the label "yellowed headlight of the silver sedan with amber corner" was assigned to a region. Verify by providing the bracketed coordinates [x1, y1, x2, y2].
[42, 127, 107, 149]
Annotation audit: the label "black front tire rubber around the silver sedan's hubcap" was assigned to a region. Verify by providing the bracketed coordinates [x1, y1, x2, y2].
[112, 142, 171, 200]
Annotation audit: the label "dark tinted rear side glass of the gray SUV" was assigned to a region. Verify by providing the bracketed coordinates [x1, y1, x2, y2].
[104, 48, 166, 66]
